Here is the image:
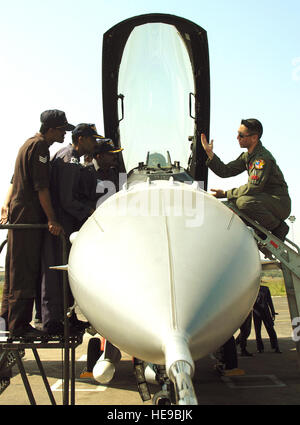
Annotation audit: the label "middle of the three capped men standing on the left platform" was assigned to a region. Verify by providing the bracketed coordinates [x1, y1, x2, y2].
[42, 123, 102, 335]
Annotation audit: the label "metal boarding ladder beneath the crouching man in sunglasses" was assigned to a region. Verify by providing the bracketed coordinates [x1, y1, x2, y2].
[223, 201, 300, 366]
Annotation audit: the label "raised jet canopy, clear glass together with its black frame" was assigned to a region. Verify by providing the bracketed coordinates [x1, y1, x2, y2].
[103, 14, 210, 185]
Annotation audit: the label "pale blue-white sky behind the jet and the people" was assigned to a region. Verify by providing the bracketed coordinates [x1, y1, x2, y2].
[0, 0, 300, 264]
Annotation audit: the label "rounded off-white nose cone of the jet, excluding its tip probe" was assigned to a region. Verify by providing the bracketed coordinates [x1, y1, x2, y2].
[69, 181, 261, 364]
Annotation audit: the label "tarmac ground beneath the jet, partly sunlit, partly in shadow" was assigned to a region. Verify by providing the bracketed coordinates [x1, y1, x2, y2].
[0, 297, 300, 406]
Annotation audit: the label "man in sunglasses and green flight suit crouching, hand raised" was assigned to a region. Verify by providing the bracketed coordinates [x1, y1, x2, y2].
[201, 118, 291, 240]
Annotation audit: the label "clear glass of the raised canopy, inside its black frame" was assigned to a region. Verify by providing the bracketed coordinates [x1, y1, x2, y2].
[118, 23, 195, 172]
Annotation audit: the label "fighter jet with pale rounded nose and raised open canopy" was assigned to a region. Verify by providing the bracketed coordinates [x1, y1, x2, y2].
[68, 14, 261, 404]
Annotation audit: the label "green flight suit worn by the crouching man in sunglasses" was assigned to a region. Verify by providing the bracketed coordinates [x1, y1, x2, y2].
[206, 141, 291, 230]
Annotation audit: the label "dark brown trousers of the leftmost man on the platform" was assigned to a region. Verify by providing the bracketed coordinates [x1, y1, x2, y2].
[1, 229, 44, 332]
